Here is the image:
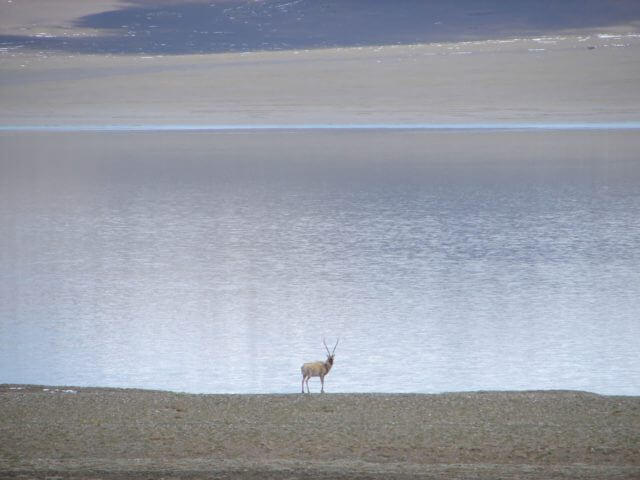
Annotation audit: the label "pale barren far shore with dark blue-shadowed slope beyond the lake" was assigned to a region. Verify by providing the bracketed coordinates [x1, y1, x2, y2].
[0, 0, 640, 125]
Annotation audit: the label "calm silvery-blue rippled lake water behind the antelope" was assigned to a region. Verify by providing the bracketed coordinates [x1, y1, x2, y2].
[0, 132, 640, 395]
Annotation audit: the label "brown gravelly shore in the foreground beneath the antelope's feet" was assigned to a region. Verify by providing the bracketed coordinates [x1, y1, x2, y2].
[0, 385, 640, 479]
